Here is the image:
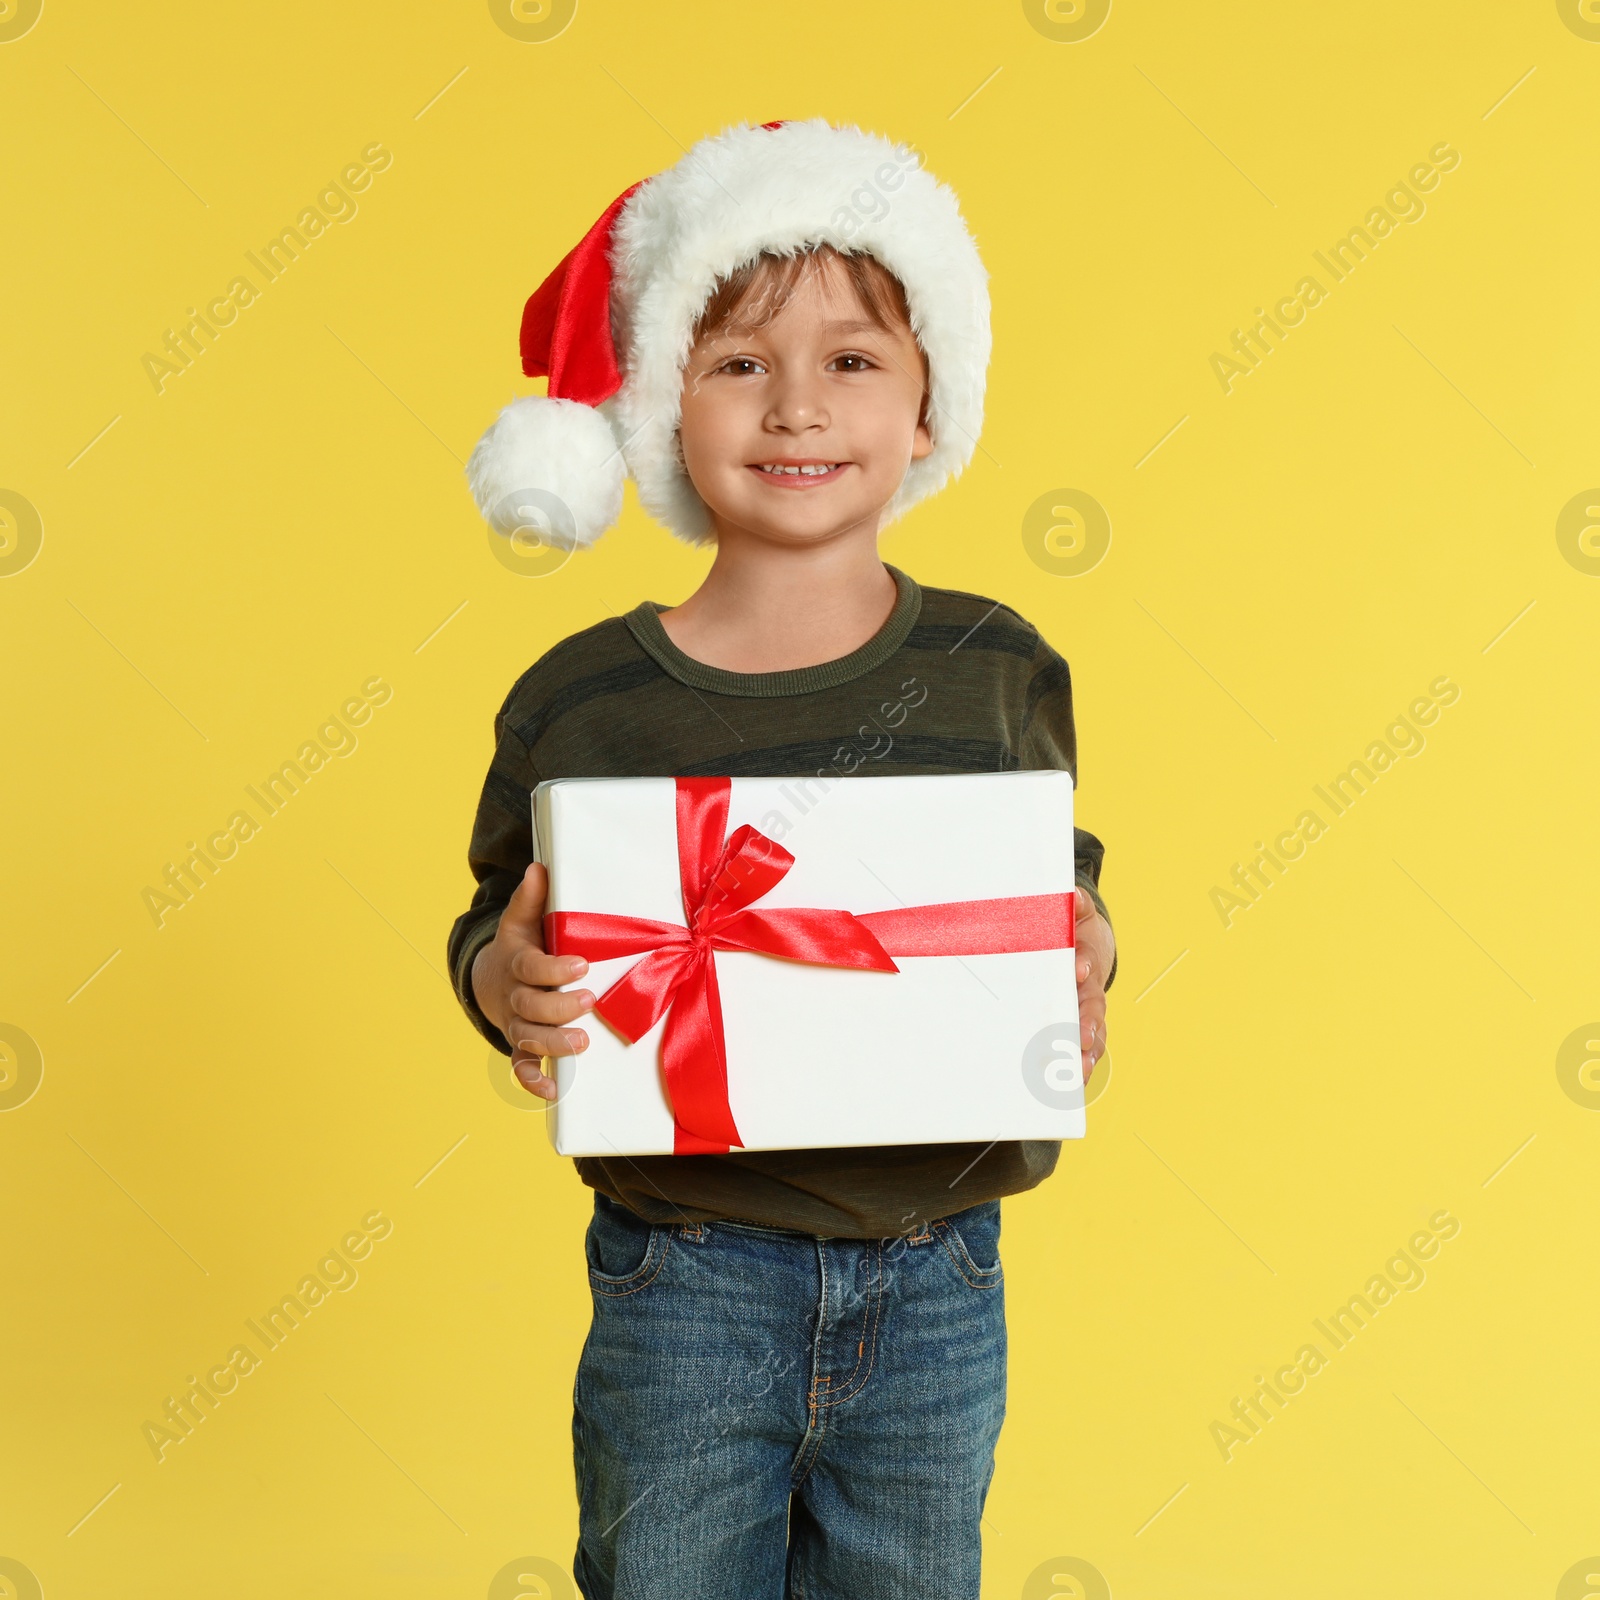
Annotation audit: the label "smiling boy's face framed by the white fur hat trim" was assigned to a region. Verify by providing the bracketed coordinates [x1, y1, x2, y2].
[680, 256, 933, 546]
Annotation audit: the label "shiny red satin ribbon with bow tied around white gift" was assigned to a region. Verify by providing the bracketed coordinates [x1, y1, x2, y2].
[544, 778, 1074, 1155]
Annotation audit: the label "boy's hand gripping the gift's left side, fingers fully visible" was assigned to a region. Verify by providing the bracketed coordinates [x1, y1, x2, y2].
[472, 861, 595, 1099]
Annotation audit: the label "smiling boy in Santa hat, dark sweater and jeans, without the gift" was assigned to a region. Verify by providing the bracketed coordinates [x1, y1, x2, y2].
[450, 122, 1115, 1600]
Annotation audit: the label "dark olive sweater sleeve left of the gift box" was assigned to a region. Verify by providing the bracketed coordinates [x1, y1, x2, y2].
[448, 706, 539, 1056]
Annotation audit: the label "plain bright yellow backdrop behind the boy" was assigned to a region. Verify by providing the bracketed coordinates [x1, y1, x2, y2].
[0, 0, 1600, 1600]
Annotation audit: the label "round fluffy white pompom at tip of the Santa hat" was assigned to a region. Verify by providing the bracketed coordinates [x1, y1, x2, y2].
[467, 395, 627, 549]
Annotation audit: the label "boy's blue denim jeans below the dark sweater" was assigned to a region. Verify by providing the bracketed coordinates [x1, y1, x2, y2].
[573, 1190, 1006, 1600]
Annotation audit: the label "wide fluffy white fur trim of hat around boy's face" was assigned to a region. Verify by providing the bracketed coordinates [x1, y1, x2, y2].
[611, 118, 990, 544]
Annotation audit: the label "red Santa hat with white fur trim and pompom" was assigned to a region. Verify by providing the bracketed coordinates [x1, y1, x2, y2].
[467, 118, 989, 547]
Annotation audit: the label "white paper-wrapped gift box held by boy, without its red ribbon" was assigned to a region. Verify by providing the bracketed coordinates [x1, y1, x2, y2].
[533, 771, 1085, 1155]
